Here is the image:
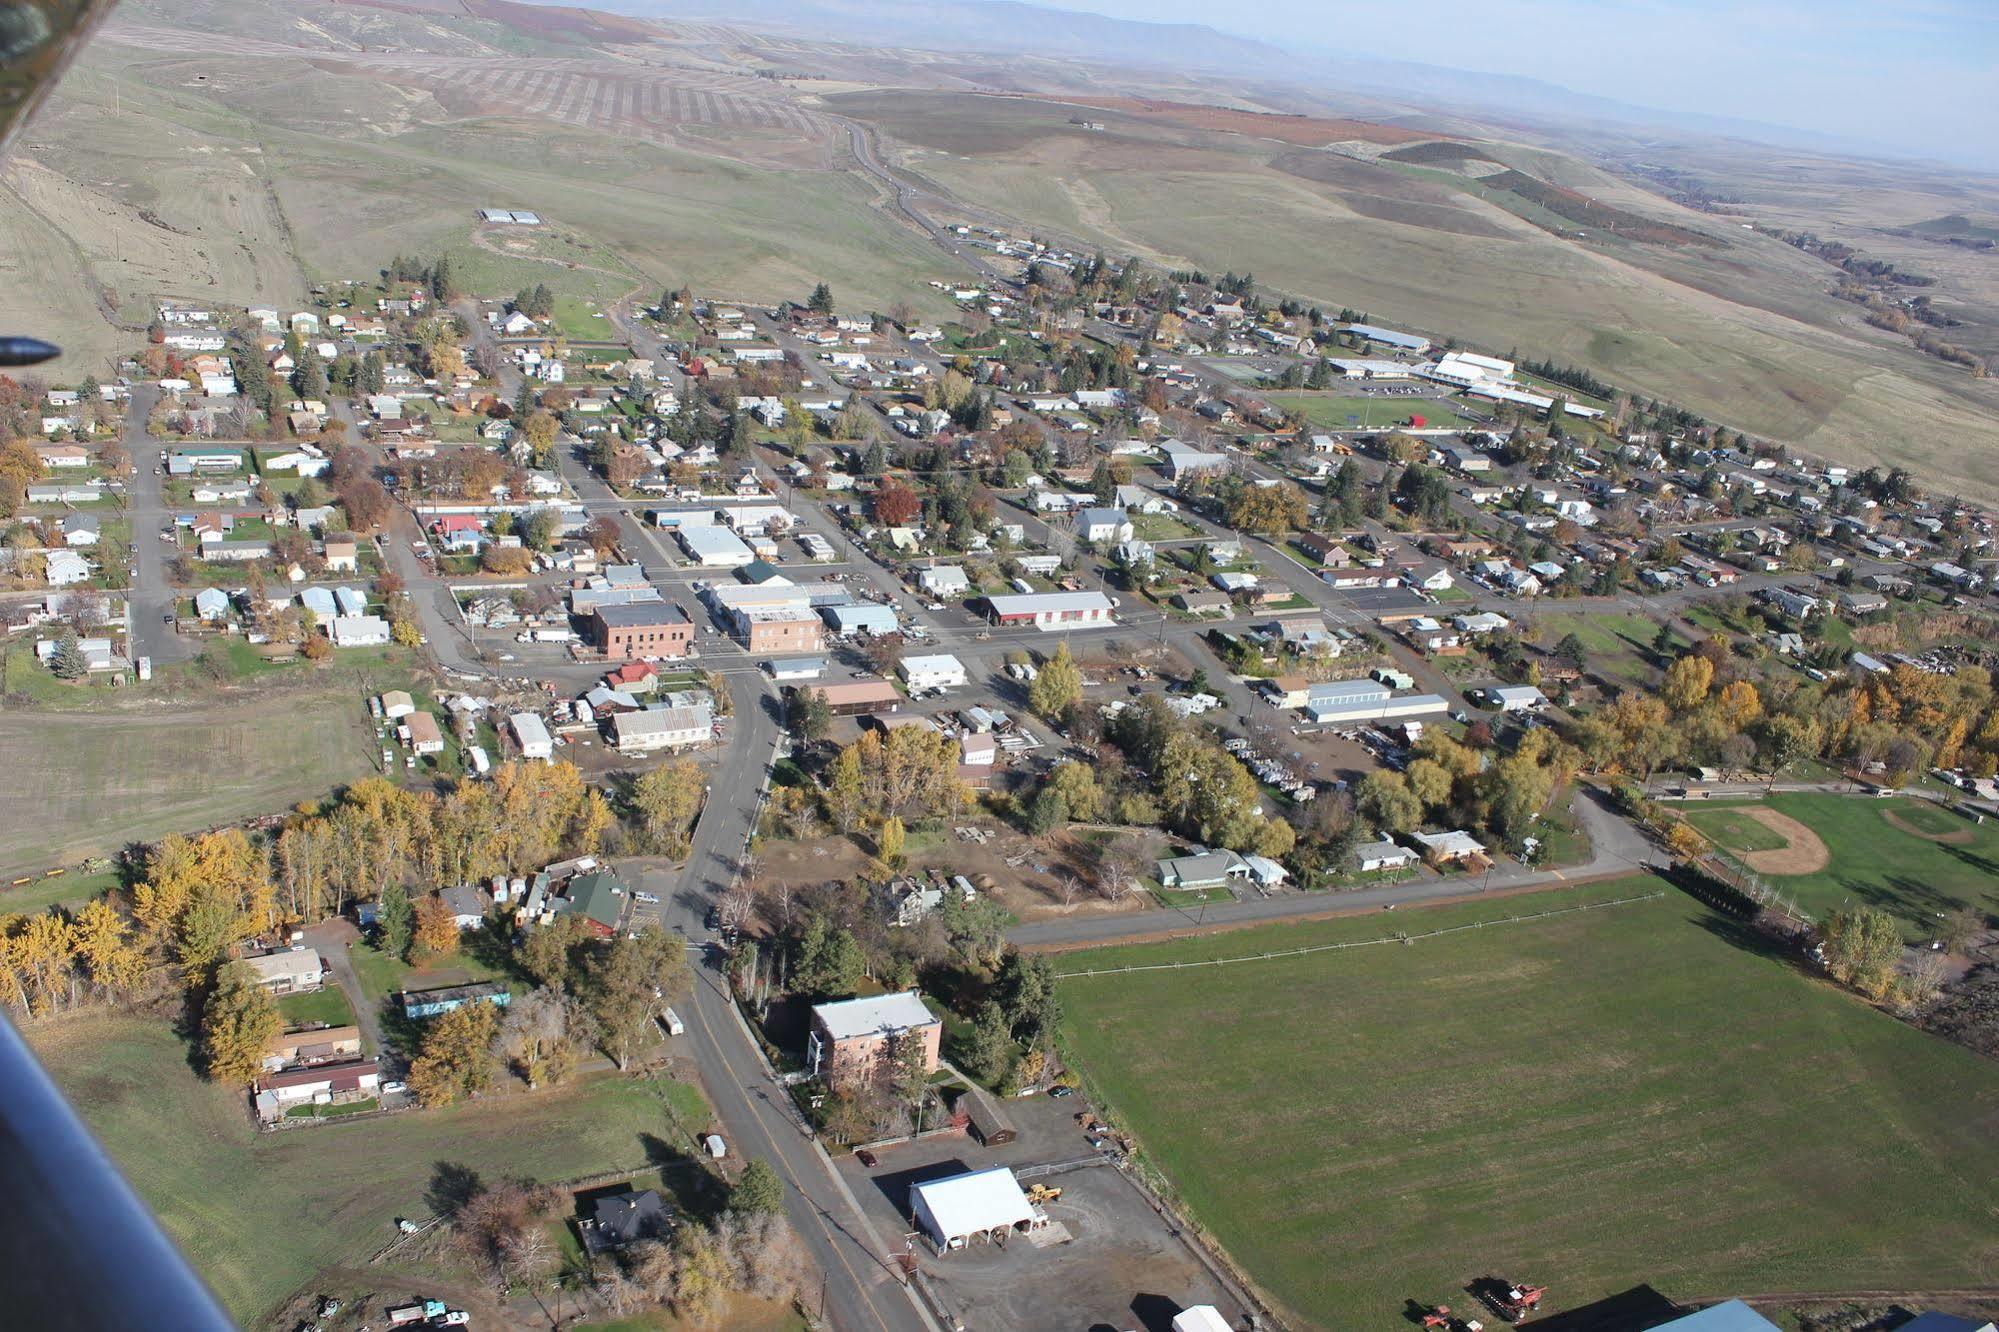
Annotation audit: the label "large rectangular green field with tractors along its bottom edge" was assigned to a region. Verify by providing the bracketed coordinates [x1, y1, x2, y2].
[1057, 878, 1999, 1328]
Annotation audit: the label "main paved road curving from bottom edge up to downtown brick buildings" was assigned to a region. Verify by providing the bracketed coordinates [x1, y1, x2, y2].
[634, 674, 936, 1332]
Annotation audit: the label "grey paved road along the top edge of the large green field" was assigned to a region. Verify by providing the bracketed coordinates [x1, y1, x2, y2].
[1007, 788, 1659, 948]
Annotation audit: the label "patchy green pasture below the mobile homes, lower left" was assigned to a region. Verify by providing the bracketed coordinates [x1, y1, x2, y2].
[28, 1014, 711, 1326]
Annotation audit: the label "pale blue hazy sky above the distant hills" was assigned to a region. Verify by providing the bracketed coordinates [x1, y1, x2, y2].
[1041, 0, 1999, 166]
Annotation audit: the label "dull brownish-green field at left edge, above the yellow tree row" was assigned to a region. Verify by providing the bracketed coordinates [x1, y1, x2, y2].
[0, 690, 370, 872]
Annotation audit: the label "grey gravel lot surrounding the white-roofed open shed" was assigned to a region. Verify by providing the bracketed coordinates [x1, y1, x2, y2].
[836, 1096, 1243, 1332]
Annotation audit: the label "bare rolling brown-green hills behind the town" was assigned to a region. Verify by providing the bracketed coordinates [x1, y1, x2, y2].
[0, 0, 1999, 496]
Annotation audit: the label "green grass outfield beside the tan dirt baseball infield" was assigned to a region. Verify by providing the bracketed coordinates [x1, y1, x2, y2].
[1769, 792, 1999, 942]
